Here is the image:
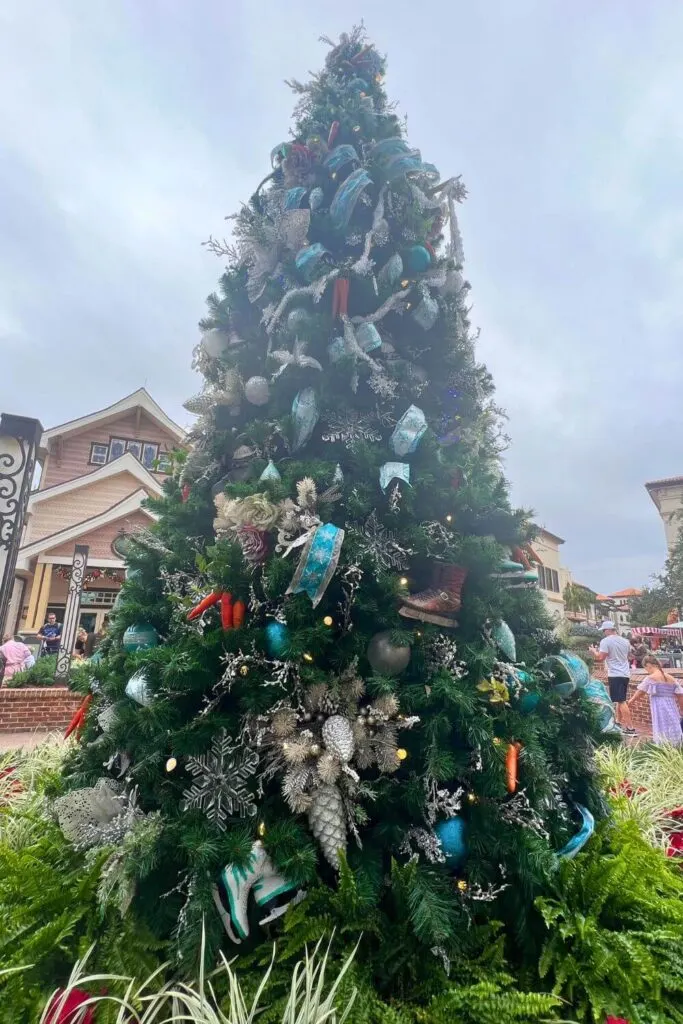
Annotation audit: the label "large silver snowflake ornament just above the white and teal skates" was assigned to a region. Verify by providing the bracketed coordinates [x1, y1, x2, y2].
[182, 729, 259, 831]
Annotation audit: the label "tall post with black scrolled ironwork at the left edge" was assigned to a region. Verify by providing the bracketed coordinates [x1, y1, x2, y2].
[0, 413, 43, 636]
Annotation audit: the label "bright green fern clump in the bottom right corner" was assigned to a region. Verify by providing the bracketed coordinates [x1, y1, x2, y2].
[536, 822, 683, 1024]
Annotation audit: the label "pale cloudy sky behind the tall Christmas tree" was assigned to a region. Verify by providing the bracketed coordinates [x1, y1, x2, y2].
[0, 0, 683, 593]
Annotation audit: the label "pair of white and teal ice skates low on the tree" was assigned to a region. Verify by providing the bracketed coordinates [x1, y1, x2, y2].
[213, 840, 305, 945]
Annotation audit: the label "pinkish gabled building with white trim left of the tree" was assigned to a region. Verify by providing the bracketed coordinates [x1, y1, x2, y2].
[7, 388, 184, 633]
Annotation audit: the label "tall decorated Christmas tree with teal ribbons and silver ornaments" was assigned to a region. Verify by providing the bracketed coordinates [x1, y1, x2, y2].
[63, 30, 610, 989]
